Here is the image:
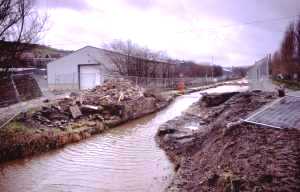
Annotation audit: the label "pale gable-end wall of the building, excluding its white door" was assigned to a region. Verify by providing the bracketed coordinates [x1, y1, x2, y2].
[47, 46, 112, 89]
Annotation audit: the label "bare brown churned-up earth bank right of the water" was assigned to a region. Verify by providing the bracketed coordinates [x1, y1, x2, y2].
[156, 92, 300, 192]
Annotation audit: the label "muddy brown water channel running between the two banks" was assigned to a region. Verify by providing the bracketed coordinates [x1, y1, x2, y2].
[0, 86, 246, 192]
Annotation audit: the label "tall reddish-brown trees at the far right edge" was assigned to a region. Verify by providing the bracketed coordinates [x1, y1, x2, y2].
[271, 18, 300, 80]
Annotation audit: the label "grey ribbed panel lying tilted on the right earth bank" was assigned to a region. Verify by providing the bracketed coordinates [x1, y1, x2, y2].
[244, 96, 300, 129]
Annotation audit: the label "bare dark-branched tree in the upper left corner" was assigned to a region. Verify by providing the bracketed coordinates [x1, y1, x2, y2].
[0, 0, 47, 77]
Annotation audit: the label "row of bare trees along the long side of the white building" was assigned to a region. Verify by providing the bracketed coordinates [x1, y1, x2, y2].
[104, 40, 223, 78]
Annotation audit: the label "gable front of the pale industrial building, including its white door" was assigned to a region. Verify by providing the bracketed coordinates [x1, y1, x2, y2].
[47, 46, 113, 90]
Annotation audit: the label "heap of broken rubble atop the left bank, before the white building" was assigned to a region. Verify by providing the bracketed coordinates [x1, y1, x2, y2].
[27, 79, 165, 130]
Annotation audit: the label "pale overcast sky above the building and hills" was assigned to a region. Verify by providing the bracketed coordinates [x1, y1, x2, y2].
[38, 0, 300, 66]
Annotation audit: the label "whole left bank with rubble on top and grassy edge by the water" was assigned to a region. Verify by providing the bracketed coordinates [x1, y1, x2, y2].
[0, 80, 173, 162]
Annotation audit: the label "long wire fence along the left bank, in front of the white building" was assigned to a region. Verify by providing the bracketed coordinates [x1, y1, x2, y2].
[0, 73, 229, 107]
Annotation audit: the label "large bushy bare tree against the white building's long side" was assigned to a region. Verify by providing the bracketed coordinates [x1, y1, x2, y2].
[104, 40, 172, 77]
